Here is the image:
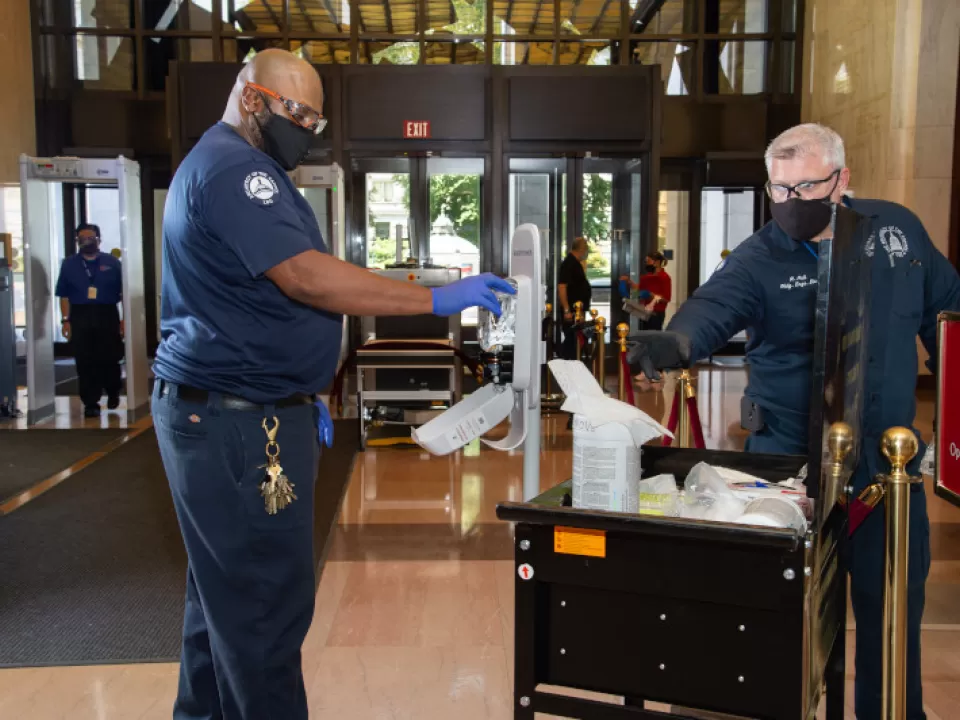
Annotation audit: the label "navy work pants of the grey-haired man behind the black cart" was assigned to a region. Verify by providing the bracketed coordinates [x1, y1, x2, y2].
[746, 417, 930, 720]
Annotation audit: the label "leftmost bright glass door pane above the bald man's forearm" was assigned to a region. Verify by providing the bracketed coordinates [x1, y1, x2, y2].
[367, 173, 413, 268]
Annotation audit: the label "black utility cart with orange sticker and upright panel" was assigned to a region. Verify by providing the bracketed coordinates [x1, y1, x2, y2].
[497, 208, 869, 720]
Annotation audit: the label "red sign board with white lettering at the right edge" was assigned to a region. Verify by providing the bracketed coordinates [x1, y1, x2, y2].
[936, 313, 960, 505]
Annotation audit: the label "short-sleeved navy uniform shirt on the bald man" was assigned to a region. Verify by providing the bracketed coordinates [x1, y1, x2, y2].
[154, 123, 342, 403]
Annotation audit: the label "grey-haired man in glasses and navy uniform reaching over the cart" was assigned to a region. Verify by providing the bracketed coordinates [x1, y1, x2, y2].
[629, 124, 960, 720]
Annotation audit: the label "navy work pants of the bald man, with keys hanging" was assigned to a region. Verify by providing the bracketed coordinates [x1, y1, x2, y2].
[153, 380, 320, 720]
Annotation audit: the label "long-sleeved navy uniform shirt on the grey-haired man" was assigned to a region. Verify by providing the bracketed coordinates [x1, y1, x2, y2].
[668, 199, 960, 474]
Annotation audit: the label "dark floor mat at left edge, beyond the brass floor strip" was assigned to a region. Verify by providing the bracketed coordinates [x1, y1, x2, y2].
[0, 429, 126, 503]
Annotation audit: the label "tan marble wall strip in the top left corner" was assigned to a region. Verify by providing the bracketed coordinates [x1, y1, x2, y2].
[0, 0, 36, 185]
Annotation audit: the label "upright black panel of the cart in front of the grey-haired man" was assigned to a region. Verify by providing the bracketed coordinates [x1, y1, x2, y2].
[807, 205, 871, 506]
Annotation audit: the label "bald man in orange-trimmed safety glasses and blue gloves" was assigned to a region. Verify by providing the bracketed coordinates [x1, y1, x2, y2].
[153, 50, 513, 720]
